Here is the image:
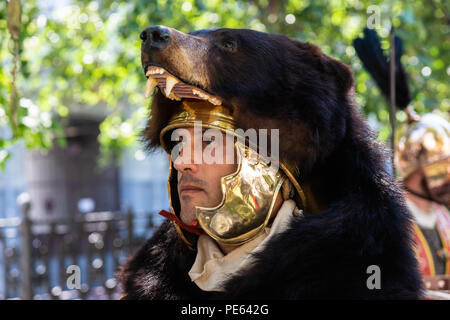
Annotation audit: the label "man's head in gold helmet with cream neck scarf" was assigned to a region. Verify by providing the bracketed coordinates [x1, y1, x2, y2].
[161, 99, 304, 291]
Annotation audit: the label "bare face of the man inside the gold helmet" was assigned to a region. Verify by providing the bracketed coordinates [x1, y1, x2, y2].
[174, 128, 237, 224]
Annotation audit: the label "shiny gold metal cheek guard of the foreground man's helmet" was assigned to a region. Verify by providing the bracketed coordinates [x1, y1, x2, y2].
[196, 142, 285, 245]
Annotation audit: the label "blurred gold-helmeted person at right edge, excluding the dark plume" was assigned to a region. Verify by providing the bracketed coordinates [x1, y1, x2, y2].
[395, 113, 450, 275]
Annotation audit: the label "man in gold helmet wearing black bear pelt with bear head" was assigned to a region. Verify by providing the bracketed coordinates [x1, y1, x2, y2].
[118, 26, 422, 299]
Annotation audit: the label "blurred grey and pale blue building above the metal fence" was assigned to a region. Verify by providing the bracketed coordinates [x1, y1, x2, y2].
[0, 126, 169, 218]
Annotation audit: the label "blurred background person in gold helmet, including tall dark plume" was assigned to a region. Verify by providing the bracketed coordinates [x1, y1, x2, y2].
[353, 28, 450, 275]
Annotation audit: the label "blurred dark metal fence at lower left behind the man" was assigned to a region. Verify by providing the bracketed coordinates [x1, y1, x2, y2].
[0, 195, 160, 300]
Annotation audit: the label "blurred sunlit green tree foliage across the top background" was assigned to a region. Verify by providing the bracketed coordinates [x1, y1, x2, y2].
[0, 0, 450, 168]
